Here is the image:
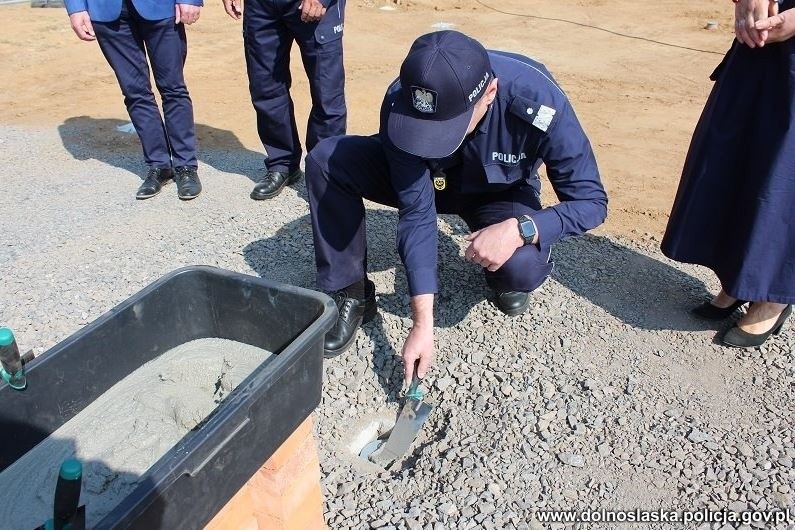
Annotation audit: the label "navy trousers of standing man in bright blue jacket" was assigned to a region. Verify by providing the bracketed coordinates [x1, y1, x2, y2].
[93, 0, 198, 169]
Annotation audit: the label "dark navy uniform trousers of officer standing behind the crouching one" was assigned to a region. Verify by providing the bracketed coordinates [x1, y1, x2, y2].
[243, 0, 347, 171]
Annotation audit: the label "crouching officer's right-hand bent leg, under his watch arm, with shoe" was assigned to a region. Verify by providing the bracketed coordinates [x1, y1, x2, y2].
[459, 186, 552, 316]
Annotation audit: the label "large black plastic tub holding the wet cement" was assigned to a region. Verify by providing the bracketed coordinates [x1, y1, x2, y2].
[0, 266, 337, 530]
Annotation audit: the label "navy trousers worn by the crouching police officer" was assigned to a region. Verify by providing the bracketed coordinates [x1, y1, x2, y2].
[306, 136, 552, 292]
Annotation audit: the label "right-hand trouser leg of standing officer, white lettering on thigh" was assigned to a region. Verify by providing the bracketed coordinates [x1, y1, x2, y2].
[285, 0, 348, 151]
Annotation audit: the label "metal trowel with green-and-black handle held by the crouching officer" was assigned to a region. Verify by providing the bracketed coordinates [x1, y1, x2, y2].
[369, 370, 433, 468]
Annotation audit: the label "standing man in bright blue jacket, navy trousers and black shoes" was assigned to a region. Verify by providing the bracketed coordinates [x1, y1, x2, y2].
[66, 0, 202, 200]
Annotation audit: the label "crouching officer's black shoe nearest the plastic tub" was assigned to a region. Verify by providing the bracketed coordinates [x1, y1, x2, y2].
[323, 280, 378, 359]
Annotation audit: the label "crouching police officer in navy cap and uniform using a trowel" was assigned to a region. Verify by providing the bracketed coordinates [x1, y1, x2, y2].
[306, 31, 607, 380]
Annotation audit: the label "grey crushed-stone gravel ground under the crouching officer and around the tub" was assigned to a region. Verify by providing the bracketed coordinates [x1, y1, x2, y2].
[0, 120, 795, 530]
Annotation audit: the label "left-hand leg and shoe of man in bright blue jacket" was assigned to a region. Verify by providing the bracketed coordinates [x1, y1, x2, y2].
[93, 0, 171, 199]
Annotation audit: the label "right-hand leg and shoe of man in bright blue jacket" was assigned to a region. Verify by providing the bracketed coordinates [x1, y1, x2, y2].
[134, 8, 201, 199]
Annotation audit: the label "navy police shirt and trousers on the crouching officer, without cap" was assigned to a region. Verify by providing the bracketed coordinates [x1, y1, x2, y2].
[306, 40, 607, 296]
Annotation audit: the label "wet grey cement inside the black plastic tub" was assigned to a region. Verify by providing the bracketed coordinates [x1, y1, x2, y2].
[0, 339, 272, 530]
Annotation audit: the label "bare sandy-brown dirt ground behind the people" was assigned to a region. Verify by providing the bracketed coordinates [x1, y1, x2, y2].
[0, 0, 733, 237]
